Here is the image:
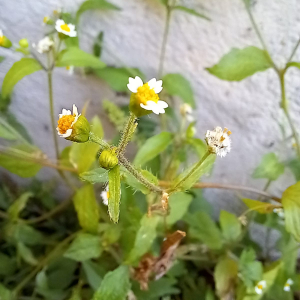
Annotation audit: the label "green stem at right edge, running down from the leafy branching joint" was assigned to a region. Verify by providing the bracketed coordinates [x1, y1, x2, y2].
[278, 69, 300, 158]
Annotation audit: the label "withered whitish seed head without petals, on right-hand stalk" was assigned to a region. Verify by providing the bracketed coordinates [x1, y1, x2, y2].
[205, 127, 231, 157]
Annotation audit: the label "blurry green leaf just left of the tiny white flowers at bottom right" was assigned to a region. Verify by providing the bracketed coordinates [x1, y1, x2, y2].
[239, 248, 263, 287]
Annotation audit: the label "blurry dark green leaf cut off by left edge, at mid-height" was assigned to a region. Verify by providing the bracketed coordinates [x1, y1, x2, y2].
[0, 144, 42, 178]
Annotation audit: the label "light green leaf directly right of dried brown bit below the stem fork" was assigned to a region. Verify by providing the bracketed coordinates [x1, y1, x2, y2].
[167, 193, 193, 225]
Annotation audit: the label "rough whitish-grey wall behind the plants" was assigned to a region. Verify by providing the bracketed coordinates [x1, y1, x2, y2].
[0, 0, 300, 216]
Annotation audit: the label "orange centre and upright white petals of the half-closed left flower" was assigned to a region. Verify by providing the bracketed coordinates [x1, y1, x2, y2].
[56, 104, 80, 138]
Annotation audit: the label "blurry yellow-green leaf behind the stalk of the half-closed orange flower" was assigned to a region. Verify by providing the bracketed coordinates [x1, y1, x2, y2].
[69, 117, 103, 173]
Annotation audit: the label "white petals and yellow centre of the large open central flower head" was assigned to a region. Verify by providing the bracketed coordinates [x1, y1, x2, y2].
[127, 76, 168, 115]
